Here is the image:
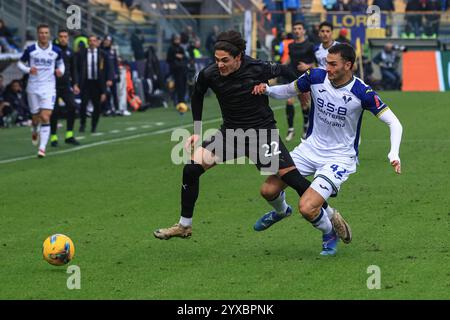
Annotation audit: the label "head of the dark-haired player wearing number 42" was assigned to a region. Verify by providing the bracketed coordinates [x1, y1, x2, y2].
[326, 43, 356, 82]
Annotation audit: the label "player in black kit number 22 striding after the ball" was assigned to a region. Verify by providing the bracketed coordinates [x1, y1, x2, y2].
[153, 31, 340, 240]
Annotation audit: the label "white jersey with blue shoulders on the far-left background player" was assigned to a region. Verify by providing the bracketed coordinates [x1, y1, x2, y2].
[20, 42, 64, 93]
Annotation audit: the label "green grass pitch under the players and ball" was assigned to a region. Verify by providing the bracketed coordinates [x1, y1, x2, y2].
[0, 92, 450, 300]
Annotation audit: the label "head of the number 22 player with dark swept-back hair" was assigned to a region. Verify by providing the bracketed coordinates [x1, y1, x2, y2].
[214, 30, 246, 76]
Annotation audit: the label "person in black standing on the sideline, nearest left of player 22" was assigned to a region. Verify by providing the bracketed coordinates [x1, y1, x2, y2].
[167, 35, 188, 104]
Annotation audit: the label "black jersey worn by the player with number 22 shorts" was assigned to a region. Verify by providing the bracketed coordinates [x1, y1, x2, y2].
[192, 56, 292, 129]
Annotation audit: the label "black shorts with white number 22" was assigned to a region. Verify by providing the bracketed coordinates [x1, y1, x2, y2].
[202, 127, 295, 174]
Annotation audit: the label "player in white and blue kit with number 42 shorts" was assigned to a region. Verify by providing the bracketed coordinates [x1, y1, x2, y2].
[253, 44, 402, 255]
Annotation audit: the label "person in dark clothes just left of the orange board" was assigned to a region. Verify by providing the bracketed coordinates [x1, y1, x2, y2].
[373, 42, 401, 90]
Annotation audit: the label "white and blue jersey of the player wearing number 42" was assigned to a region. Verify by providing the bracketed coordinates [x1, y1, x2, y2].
[295, 68, 389, 158]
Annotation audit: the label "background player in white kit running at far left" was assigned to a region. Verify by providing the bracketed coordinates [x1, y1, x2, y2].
[17, 24, 65, 158]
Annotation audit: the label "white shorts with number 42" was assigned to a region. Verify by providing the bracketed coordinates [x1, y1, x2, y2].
[291, 143, 357, 200]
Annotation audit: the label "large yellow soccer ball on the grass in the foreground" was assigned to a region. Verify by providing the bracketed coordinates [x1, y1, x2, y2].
[42, 234, 75, 266]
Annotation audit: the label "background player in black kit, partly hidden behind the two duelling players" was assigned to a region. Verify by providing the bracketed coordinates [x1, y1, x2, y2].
[286, 22, 316, 141]
